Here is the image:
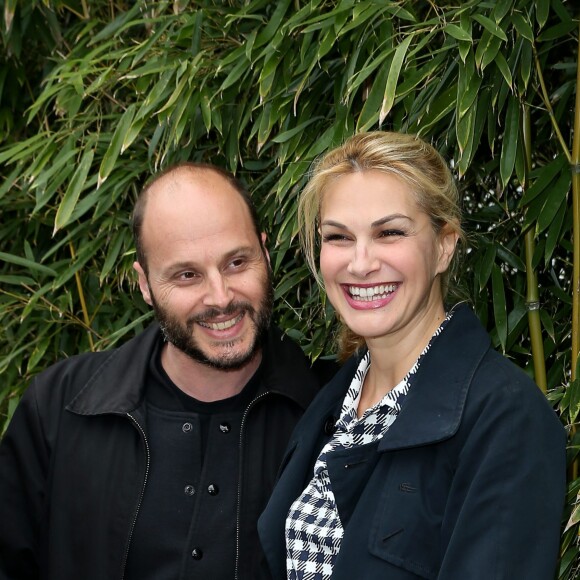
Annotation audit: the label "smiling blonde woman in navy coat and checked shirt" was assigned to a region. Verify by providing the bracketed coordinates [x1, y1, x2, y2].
[259, 132, 565, 580]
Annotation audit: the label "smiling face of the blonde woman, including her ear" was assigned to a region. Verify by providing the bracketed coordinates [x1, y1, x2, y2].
[320, 170, 457, 340]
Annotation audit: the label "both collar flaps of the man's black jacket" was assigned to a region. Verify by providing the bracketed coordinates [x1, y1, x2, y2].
[66, 323, 317, 415]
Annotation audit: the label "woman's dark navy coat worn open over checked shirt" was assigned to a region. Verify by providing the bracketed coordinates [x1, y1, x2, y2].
[258, 307, 566, 580]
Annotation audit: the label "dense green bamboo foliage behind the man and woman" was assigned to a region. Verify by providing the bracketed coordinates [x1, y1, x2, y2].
[0, 0, 580, 579]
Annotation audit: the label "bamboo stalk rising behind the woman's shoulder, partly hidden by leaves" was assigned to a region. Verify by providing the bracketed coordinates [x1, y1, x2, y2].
[522, 104, 548, 393]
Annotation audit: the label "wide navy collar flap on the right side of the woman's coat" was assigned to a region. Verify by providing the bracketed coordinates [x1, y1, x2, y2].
[379, 305, 490, 451]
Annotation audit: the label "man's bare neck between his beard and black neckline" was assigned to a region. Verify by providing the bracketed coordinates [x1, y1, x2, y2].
[156, 343, 262, 403]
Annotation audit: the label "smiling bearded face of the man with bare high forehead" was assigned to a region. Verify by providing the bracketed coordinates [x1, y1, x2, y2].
[135, 170, 273, 370]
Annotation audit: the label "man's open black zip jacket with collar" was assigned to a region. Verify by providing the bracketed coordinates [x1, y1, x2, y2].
[0, 325, 317, 580]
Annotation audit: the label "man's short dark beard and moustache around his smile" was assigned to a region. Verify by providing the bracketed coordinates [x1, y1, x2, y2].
[151, 266, 274, 371]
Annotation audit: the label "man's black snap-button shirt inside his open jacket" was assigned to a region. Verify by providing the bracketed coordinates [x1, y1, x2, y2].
[125, 342, 260, 580]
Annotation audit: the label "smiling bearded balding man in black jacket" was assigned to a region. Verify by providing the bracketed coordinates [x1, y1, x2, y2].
[0, 164, 317, 580]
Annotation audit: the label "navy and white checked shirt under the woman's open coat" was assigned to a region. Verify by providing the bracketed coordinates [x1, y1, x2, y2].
[286, 312, 452, 580]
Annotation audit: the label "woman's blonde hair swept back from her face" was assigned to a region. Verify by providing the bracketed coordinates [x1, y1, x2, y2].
[298, 131, 464, 358]
